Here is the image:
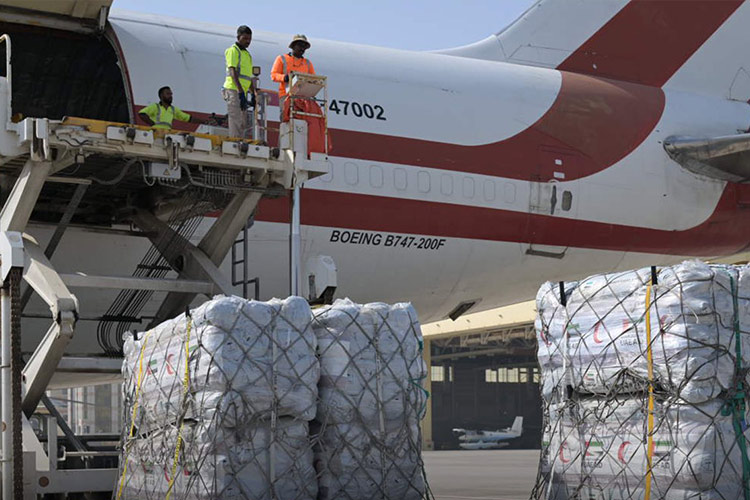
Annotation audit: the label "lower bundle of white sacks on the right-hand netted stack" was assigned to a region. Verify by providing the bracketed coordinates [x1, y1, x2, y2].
[550, 395, 742, 499]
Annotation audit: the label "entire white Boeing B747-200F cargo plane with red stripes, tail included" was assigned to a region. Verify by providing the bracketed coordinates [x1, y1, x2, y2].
[0, 0, 750, 364]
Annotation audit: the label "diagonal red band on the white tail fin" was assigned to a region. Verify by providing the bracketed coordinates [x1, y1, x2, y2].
[557, 0, 744, 87]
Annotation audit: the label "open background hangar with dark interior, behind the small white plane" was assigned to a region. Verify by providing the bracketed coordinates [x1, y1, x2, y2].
[422, 301, 542, 450]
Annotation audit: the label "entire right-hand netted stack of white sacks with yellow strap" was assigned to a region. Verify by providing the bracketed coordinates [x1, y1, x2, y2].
[532, 261, 750, 500]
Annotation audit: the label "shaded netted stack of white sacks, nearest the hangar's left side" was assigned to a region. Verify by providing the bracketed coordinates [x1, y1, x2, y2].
[314, 300, 427, 500]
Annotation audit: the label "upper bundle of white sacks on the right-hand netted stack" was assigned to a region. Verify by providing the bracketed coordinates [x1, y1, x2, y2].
[537, 261, 750, 403]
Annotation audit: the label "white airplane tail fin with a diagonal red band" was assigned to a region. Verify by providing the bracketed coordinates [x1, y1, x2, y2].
[442, 0, 750, 100]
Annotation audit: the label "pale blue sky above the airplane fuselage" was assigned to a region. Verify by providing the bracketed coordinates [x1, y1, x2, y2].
[113, 0, 533, 50]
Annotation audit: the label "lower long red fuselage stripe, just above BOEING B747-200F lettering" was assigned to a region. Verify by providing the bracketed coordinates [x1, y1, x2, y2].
[256, 188, 750, 256]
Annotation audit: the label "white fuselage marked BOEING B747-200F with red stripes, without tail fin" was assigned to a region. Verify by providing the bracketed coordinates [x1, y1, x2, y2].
[13, 6, 750, 356]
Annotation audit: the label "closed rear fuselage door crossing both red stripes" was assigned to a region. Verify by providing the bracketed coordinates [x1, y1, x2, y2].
[526, 146, 580, 259]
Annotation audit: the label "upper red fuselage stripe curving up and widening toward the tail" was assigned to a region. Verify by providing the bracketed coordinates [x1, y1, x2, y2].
[333, 72, 664, 182]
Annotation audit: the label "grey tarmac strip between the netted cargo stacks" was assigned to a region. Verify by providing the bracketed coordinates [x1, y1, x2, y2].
[422, 450, 539, 500]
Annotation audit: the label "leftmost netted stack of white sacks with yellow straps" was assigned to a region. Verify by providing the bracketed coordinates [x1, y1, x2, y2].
[118, 297, 320, 500]
